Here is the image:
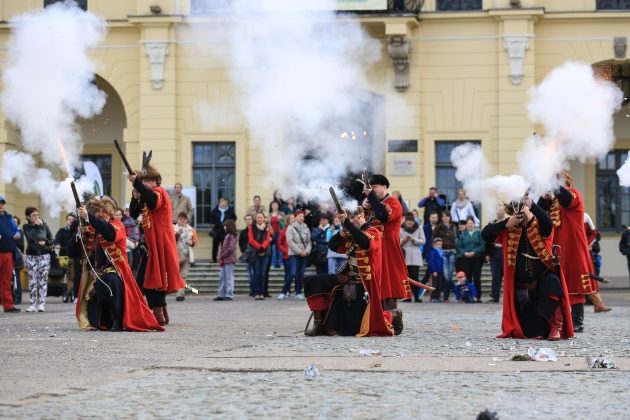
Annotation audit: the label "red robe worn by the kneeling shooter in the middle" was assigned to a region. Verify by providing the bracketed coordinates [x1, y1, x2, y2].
[329, 226, 394, 337]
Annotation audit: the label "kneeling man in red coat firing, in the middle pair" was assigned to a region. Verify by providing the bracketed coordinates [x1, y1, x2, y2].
[304, 208, 402, 337]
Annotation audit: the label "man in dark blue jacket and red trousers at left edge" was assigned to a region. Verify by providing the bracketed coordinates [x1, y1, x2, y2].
[0, 195, 20, 312]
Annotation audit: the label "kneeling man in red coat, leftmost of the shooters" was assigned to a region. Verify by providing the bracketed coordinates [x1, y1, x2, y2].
[72, 196, 164, 331]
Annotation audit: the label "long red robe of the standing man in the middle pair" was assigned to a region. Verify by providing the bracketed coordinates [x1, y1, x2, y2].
[370, 196, 411, 299]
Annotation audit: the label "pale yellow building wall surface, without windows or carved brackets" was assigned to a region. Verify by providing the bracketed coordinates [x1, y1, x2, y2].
[0, 0, 630, 278]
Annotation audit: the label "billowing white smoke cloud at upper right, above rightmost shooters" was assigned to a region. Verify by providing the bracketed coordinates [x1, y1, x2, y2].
[518, 62, 623, 194]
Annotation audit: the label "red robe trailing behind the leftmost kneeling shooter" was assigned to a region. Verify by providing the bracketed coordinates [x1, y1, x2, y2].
[76, 220, 164, 331]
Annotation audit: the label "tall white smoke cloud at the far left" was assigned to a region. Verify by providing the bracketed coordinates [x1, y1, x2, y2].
[1, 3, 106, 216]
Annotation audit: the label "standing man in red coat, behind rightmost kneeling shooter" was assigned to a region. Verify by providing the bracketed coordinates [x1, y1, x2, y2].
[538, 172, 598, 332]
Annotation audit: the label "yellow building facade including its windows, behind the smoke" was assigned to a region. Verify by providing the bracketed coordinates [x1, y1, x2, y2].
[0, 0, 630, 284]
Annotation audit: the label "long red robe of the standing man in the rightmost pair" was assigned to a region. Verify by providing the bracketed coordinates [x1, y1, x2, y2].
[549, 187, 597, 304]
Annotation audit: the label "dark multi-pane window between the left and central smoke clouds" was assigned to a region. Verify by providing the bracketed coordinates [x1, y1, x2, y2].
[192, 142, 236, 228]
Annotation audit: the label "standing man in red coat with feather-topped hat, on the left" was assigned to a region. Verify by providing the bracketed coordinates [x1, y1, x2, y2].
[127, 165, 186, 325]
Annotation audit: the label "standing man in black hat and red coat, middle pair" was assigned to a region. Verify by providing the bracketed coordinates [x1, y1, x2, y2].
[363, 174, 411, 316]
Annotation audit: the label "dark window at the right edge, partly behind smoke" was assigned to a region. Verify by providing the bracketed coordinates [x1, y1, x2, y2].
[596, 150, 630, 230]
